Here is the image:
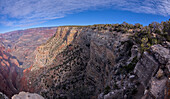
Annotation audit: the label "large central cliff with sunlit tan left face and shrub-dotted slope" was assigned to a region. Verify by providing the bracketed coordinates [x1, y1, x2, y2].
[26, 27, 137, 98]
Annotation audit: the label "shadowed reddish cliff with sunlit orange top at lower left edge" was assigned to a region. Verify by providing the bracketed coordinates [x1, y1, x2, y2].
[0, 46, 22, 97]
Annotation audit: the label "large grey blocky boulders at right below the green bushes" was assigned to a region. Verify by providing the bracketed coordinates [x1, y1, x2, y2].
[135, 45, 170, 99]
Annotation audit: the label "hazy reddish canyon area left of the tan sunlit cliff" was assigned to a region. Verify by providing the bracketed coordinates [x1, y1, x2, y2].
[0, 27, 56, 97]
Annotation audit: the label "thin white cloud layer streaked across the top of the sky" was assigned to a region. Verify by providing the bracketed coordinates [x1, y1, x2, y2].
[0, 0, 170, 26]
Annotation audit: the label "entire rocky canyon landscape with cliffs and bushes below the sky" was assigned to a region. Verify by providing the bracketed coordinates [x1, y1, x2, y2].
[0, 21, 170, 99]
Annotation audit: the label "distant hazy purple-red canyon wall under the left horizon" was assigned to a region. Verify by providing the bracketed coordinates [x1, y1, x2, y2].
[0, 27, 56, 68]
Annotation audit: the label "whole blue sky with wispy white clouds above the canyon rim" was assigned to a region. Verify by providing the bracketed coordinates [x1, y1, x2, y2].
[0, 0, 170, 33]
